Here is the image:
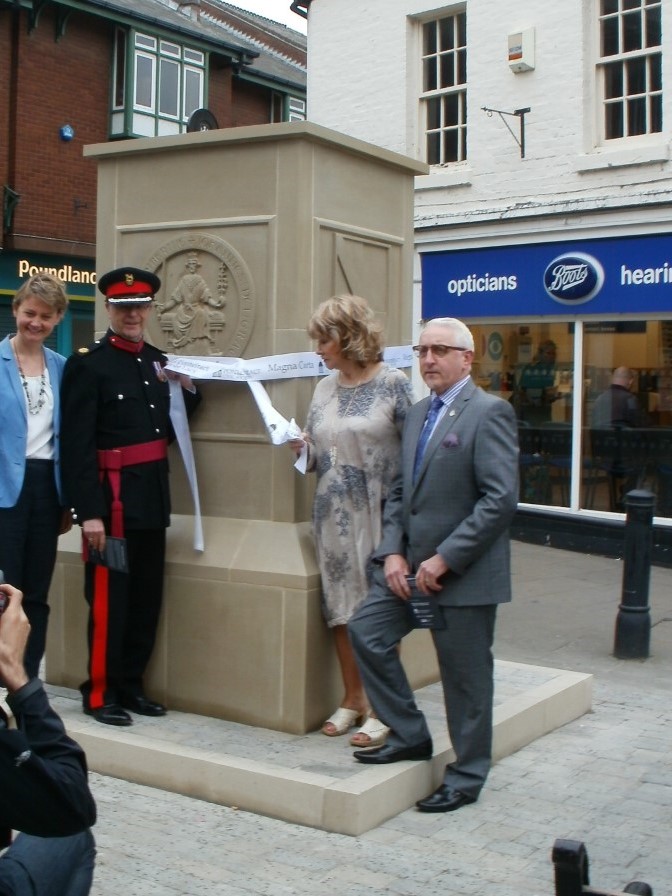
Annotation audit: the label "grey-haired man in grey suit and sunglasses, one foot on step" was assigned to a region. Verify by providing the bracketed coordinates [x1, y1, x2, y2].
[349, 318, 518, 812]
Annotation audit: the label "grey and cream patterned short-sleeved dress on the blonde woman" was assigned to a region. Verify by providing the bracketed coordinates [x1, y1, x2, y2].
[306, 364, 413, 627]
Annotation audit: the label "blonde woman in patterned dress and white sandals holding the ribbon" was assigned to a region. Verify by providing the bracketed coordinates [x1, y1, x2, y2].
[291, 295, 413, 747]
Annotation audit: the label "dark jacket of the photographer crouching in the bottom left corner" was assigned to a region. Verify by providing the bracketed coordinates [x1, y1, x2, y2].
[0, 678, 96, 848]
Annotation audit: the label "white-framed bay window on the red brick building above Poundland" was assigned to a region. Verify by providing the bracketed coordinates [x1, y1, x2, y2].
[111, 28, 206, 137]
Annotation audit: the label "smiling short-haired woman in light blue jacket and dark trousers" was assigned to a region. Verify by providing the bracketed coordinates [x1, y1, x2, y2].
[0, 273, 71, 678]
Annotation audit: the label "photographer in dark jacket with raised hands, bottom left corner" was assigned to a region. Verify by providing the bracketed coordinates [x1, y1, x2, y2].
[0, 584, 96, 896]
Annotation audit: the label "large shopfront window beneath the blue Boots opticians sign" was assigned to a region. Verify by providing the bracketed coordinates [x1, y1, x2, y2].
[470, 319, 672, 517]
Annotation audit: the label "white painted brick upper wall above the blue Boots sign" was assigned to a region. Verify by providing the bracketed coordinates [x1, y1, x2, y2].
[308, 0, 672, 226]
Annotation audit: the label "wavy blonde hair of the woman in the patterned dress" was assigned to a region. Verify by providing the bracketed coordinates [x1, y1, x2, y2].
[306, 295, 383, 365]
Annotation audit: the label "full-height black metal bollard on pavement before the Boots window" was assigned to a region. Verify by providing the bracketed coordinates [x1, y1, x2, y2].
[614, 489, 655, 660]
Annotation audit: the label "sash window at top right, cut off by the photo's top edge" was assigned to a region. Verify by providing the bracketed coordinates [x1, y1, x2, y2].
[597, 0, 663, 140]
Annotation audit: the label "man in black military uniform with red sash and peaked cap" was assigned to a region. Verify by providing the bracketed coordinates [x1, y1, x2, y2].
[61, 267, 200, 725]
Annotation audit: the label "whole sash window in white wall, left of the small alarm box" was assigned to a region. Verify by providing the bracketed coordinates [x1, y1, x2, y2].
[420, 12, 467, 165]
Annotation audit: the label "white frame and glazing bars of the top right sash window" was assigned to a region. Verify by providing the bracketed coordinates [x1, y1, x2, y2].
[596, 0, 664, 147]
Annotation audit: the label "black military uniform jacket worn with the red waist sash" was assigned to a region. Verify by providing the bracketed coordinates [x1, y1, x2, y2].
[61, 331, 190, 530]
